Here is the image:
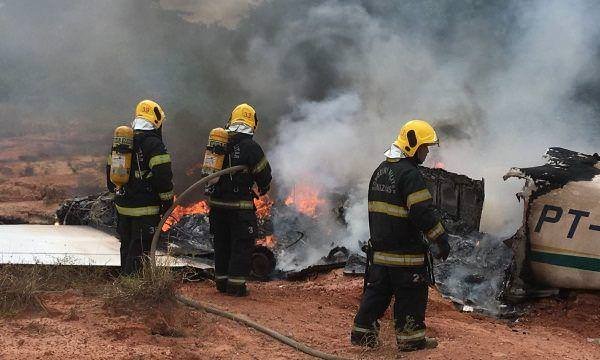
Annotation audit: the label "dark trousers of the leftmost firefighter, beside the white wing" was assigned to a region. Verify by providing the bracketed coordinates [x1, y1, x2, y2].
[117, 215, 160, 275]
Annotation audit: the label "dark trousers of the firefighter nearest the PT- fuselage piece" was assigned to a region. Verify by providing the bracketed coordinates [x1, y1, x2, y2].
[351, 264, 429, 347]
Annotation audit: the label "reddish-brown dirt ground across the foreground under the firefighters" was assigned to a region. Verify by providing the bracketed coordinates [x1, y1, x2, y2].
[0, 270, 600, 359]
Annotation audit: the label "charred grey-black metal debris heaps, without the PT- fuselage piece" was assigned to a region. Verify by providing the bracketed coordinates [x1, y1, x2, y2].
[57, 168, 511, 314]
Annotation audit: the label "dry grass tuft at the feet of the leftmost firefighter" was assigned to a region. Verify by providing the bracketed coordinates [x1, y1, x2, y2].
[104, 259, 177, 307]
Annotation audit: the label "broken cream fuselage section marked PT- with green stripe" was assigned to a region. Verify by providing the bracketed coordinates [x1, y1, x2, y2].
[504, 148, 600, 296]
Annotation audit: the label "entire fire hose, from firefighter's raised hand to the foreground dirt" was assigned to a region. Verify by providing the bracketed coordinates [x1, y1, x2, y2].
[150, 165, 354, 360]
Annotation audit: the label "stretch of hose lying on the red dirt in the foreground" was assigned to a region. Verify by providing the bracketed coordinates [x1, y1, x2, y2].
[175, 294, 348, 360]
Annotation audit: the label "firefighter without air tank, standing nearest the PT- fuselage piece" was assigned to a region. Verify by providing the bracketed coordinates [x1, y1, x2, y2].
[350, 120, 450, 351]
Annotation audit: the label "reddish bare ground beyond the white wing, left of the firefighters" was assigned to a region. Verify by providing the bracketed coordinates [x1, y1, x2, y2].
[0, 133, 108, 223]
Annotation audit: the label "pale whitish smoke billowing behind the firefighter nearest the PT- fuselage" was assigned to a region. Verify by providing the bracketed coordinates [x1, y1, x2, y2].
[253, 1, 600, 253]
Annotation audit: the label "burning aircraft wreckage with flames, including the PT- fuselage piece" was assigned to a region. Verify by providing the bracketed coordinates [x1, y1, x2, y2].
[57, 148, 600, 316]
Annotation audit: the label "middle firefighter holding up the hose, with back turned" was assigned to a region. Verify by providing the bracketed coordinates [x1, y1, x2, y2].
[209, 104, 271, 296]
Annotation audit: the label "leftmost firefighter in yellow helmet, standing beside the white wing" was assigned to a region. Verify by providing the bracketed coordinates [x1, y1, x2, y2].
[107, 100, 174, 275]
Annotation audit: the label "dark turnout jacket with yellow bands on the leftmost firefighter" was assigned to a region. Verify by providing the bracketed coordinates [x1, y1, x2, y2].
[107, 129, 173, 217]
